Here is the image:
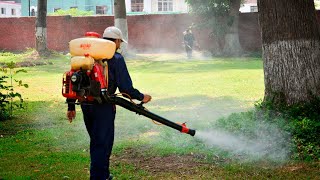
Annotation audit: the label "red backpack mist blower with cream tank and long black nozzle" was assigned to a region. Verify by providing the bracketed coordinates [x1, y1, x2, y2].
[62, 32, 196, 136]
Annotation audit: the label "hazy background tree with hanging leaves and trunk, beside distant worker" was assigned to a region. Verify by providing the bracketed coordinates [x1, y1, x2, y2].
[186, 0, 242, 55]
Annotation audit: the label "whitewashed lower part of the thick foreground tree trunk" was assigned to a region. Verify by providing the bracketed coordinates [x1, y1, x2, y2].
[262, 39, 320, 105]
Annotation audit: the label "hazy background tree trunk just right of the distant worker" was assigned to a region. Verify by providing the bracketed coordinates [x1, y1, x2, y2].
[223, 0, 242, 55]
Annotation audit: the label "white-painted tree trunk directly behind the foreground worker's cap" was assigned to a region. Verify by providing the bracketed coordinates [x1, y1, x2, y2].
[114, 0, 129, 55]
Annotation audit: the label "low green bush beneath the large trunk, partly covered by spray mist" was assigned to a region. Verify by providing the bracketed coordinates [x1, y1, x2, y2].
[212, 98, 320, 161]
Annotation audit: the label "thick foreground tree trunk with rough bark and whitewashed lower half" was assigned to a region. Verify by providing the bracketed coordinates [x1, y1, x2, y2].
[258, 0, 320, 106]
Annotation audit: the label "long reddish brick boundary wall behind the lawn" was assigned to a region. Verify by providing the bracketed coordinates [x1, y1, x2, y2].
[0, 13, 268, 52]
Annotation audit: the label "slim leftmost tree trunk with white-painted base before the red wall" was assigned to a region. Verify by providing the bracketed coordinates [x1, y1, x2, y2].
[35, 0, 48, 56]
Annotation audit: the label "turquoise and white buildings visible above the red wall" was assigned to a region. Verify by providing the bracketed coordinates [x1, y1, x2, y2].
[5, 0, 320, 17]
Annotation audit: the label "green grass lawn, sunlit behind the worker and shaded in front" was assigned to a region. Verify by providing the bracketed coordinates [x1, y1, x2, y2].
[0, 51, 319, 179]
